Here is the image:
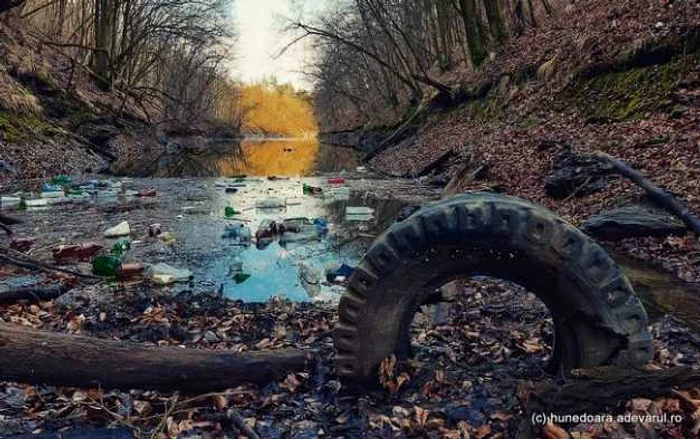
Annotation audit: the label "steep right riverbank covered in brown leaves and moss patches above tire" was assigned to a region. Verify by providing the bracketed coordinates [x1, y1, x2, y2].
[325, 0, 700, 281]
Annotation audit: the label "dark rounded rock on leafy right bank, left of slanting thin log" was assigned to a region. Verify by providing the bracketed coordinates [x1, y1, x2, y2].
[544, 151, 616, 200]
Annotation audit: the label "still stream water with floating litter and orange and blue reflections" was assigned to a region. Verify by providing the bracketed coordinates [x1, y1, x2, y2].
[0, 139, 700, 331]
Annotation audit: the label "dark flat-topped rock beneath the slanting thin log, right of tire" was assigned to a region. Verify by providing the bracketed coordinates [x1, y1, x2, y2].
[581, 205, 686, 241]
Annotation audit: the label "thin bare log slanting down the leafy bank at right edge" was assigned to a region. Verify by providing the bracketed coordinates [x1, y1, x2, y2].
[596, 151, 700, 236]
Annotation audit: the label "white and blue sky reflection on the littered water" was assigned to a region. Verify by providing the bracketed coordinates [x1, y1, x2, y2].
[172, 178, 405, 301]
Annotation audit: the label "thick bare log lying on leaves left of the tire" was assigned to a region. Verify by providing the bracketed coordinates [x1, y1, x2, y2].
[0, 323, 310, 393]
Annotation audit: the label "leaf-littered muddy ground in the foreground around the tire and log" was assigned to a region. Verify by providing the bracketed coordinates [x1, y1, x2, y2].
[0, 274, 700, 439]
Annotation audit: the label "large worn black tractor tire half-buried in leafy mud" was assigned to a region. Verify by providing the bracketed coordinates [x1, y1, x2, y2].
[335, 193, 652, 383]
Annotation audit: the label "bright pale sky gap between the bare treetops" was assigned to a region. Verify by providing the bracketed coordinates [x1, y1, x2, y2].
[233, 0, 323, 89]
